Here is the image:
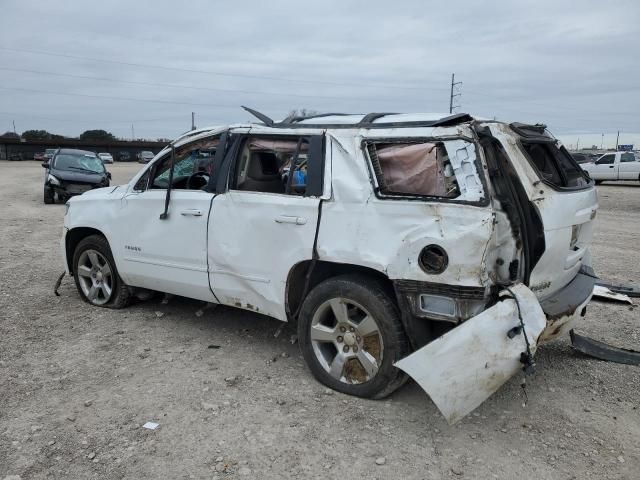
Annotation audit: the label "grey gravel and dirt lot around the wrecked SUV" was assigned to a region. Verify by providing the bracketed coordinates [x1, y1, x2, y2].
[0, 161, 640, 479]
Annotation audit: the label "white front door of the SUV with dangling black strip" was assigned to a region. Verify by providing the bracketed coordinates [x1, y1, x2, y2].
[116, 133, 218, 302]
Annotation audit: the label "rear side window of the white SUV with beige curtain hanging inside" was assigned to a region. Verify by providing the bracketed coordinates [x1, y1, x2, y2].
[367, 142, 460, 198]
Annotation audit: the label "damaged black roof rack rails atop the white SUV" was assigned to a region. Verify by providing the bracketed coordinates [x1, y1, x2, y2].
[242, 105, 473, 128]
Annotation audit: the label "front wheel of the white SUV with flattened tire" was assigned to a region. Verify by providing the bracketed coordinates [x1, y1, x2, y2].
[73, 235, 131, 309]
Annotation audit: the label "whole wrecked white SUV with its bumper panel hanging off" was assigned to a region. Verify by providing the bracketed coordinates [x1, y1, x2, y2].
[62, 111, 598, 422]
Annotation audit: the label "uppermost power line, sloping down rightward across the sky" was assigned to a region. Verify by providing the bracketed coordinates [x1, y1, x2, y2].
[0, 47, 442, 91]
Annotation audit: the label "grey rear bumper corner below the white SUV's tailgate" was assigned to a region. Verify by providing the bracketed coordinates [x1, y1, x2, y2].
[538, 266, 596, 342]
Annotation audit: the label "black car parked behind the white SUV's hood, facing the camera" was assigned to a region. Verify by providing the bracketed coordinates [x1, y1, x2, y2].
[42, 148, 111, 203]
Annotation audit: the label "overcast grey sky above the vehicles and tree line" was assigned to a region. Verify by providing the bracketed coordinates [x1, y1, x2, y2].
[0, 0, 640, 146]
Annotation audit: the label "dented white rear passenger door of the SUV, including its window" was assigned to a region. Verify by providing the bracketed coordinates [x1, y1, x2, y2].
[209, 134, 324, 320]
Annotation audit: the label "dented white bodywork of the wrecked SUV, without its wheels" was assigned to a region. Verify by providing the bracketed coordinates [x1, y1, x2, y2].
[62, 114, 598, 421]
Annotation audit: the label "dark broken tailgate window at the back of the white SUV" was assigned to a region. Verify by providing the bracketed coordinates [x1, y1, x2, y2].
[522, 142, 589, 189]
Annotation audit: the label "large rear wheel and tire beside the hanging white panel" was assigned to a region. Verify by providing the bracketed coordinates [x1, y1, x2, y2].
[298, 275, 409, 398]
